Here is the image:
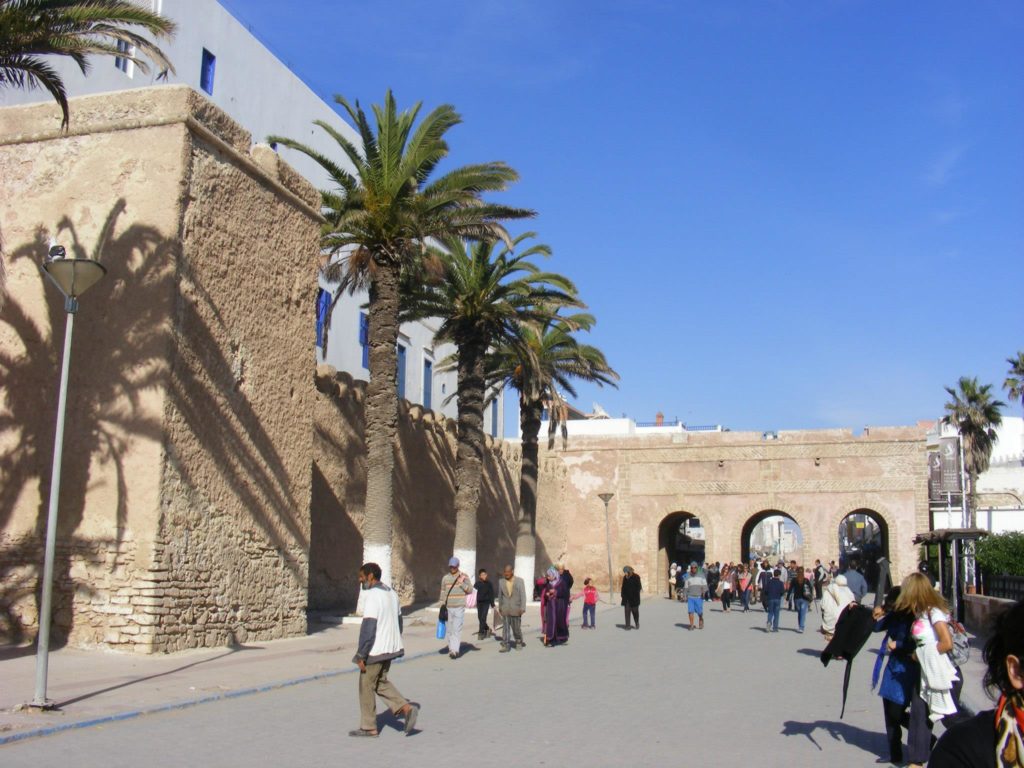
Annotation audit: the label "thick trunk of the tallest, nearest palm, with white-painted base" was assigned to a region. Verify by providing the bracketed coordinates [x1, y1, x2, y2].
[362, 264, 398, 585]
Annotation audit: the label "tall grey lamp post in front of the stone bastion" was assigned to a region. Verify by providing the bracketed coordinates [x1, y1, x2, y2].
[32, 246, 106, 710]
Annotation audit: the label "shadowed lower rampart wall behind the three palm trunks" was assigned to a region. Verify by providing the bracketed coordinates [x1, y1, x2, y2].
[309, 366, 520, 610]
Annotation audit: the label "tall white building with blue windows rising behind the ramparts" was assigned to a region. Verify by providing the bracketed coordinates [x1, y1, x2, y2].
[0, 0, 504, 435]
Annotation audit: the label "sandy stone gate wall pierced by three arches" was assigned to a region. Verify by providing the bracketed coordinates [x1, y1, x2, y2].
[538, 427, 929, 591]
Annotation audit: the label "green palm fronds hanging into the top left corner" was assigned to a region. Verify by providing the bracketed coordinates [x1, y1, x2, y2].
[0, 0, 175, 128]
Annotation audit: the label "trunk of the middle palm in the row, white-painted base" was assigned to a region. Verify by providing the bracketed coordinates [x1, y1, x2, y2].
[455, 344, 484, 577]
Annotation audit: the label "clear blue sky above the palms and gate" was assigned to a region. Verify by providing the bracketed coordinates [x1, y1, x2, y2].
[225, 0, 1024, 430]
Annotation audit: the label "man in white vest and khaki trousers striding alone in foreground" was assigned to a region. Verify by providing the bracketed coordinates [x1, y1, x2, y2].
[348, 562, 420, 736]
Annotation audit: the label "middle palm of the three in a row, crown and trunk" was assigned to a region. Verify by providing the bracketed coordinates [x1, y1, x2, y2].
[402, 232, 580, 573]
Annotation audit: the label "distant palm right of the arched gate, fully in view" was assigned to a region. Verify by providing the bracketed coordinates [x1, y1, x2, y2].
[942, 376, 1006, 528]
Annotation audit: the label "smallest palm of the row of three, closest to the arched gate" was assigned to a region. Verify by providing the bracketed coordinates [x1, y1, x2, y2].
[486, 312, 618, 579]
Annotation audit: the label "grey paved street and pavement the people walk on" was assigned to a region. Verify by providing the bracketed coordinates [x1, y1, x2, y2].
[0, 597, 984, 768]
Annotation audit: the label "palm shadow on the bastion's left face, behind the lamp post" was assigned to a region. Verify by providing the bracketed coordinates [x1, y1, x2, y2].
[0, 199, 174, 646]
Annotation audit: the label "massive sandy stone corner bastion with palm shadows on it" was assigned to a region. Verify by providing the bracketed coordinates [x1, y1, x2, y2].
[0, 86, 318, 651]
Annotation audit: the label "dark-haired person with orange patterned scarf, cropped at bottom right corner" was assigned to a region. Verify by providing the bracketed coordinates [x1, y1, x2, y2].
[928, 600, 1024, 768]
